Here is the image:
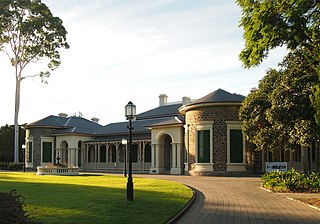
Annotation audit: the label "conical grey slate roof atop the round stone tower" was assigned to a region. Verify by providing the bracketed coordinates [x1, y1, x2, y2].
[190, 89, 245, 105]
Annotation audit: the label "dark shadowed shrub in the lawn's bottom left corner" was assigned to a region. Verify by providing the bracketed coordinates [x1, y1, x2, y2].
[0, 190, 41, 224]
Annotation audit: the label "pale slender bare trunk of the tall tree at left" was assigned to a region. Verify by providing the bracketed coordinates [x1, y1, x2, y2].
[14, 75, 21, 163]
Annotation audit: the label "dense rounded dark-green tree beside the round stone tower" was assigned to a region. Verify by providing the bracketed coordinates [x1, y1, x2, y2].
[240, 48, 320, 151]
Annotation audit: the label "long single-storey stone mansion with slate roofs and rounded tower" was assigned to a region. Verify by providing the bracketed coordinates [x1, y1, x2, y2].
[24, 89, 320, 176]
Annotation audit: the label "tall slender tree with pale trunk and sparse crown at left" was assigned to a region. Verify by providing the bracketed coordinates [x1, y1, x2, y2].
[0, 0, 69, 162]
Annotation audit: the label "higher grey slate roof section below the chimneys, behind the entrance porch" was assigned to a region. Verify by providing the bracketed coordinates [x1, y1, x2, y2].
[137, 103, 182, 120]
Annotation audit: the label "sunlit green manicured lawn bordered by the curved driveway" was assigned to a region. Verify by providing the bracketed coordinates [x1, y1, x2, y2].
[0, 172, 192, 224]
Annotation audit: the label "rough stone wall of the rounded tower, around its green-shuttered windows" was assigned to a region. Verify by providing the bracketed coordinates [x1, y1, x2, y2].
[185, 105, 261, 176]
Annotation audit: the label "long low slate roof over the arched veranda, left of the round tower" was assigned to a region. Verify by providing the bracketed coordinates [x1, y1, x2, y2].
[96, 117, 181, 135]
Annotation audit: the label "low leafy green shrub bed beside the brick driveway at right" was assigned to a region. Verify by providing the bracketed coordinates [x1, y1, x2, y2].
[261, 168, 320, 192]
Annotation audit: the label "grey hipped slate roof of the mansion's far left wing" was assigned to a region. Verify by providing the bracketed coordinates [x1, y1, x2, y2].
[25, 115, 103, 134]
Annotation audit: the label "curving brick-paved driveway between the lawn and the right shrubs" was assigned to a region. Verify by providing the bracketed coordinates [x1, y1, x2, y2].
[144, 175, 320, 224]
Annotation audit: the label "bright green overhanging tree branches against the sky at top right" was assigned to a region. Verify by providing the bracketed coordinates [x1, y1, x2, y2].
[237, 0, 320, 68]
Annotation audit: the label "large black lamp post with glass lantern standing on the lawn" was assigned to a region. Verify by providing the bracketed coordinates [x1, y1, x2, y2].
[125, 101, 136, 201]
